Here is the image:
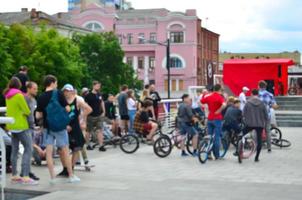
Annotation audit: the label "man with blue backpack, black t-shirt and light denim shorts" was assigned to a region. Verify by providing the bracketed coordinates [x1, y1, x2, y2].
[36, 75, 80, 184]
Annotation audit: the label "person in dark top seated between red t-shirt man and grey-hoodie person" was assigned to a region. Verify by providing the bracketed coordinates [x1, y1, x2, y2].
[223, 99, 242, 137]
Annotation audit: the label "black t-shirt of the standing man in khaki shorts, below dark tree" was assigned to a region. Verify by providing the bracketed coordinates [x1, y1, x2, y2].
[85, 92, 103, 117]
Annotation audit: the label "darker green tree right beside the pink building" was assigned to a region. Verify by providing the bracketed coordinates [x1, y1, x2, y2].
[73, 32, 142, 93]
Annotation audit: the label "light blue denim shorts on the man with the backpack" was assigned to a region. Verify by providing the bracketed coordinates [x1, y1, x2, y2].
[43, 129, 69, 148]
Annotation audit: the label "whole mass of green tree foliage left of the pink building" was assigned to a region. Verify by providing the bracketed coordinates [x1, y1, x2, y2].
[0, 24, 142, 106]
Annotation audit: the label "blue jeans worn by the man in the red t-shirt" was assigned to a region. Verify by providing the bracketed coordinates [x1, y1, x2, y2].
[208, 120, 222, 159]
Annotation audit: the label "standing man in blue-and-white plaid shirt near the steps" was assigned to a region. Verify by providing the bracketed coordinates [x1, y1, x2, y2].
[258, 81, 278, 152]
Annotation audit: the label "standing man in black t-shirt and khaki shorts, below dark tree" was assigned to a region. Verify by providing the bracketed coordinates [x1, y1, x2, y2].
[85, 81, 106, 152]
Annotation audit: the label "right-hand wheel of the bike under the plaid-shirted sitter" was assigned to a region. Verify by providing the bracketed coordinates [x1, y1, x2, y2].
[153, 135, 172, 158]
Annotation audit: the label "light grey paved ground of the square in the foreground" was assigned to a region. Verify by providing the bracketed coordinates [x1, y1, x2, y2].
[7, 128, 302, 200]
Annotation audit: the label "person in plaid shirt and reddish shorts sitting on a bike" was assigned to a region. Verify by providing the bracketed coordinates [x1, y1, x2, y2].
[133, 100, 158, 141]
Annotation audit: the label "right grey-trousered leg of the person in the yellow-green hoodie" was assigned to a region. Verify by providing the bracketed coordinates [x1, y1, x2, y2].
[19, 130, 32, 177]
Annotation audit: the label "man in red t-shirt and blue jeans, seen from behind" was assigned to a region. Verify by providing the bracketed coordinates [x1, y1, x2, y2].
[201, 84, 226, 159]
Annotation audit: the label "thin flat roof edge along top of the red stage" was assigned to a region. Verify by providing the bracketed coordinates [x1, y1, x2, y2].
[223, 58, 294, 65]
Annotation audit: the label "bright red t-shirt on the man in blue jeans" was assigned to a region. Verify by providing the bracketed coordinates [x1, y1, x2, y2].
[201, 92, 224, 120]
